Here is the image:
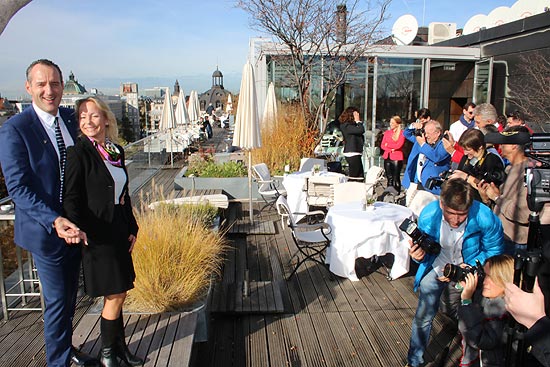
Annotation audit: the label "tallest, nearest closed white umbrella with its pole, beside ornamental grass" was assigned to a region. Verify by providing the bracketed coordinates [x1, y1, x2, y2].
[233, 62, 262, 224]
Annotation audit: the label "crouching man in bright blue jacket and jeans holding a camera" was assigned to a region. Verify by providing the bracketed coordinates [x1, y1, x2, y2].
[407, 178, 504, 367]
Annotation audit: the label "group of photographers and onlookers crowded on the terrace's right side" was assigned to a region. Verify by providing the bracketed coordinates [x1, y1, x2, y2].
[334, 102, 550, 367]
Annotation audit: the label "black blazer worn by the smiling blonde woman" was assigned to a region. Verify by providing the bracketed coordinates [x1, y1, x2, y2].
[63, 137, 138, 243]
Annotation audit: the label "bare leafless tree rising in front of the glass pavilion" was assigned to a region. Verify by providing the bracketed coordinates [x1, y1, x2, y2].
[237, 0, 391, 132]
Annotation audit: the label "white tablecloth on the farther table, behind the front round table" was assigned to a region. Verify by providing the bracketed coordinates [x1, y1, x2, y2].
[283, 171, 347, 221]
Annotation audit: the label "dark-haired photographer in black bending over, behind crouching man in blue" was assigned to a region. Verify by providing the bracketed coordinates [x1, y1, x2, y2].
[451, 129, 505, 203]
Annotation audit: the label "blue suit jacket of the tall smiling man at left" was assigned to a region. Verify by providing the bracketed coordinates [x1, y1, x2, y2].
[0, 106, 77, 256]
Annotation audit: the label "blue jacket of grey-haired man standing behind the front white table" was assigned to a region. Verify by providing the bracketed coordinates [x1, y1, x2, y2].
[402, 129, 451, 195]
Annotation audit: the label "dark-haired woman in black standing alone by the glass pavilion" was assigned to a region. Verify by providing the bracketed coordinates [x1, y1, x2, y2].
[338, 107, 365, 179]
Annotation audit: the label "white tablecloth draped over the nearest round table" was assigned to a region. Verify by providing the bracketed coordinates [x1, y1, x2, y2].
[326, 202, 413, 280]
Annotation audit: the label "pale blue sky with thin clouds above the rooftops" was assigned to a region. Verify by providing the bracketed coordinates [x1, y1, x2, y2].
[0, 0, 515, 98]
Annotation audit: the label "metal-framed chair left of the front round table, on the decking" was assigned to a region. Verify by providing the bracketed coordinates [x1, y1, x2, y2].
[275, 196, 331, 280]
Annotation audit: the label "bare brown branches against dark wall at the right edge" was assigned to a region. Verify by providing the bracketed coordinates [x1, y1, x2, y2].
[510, 53, 550, 131]
